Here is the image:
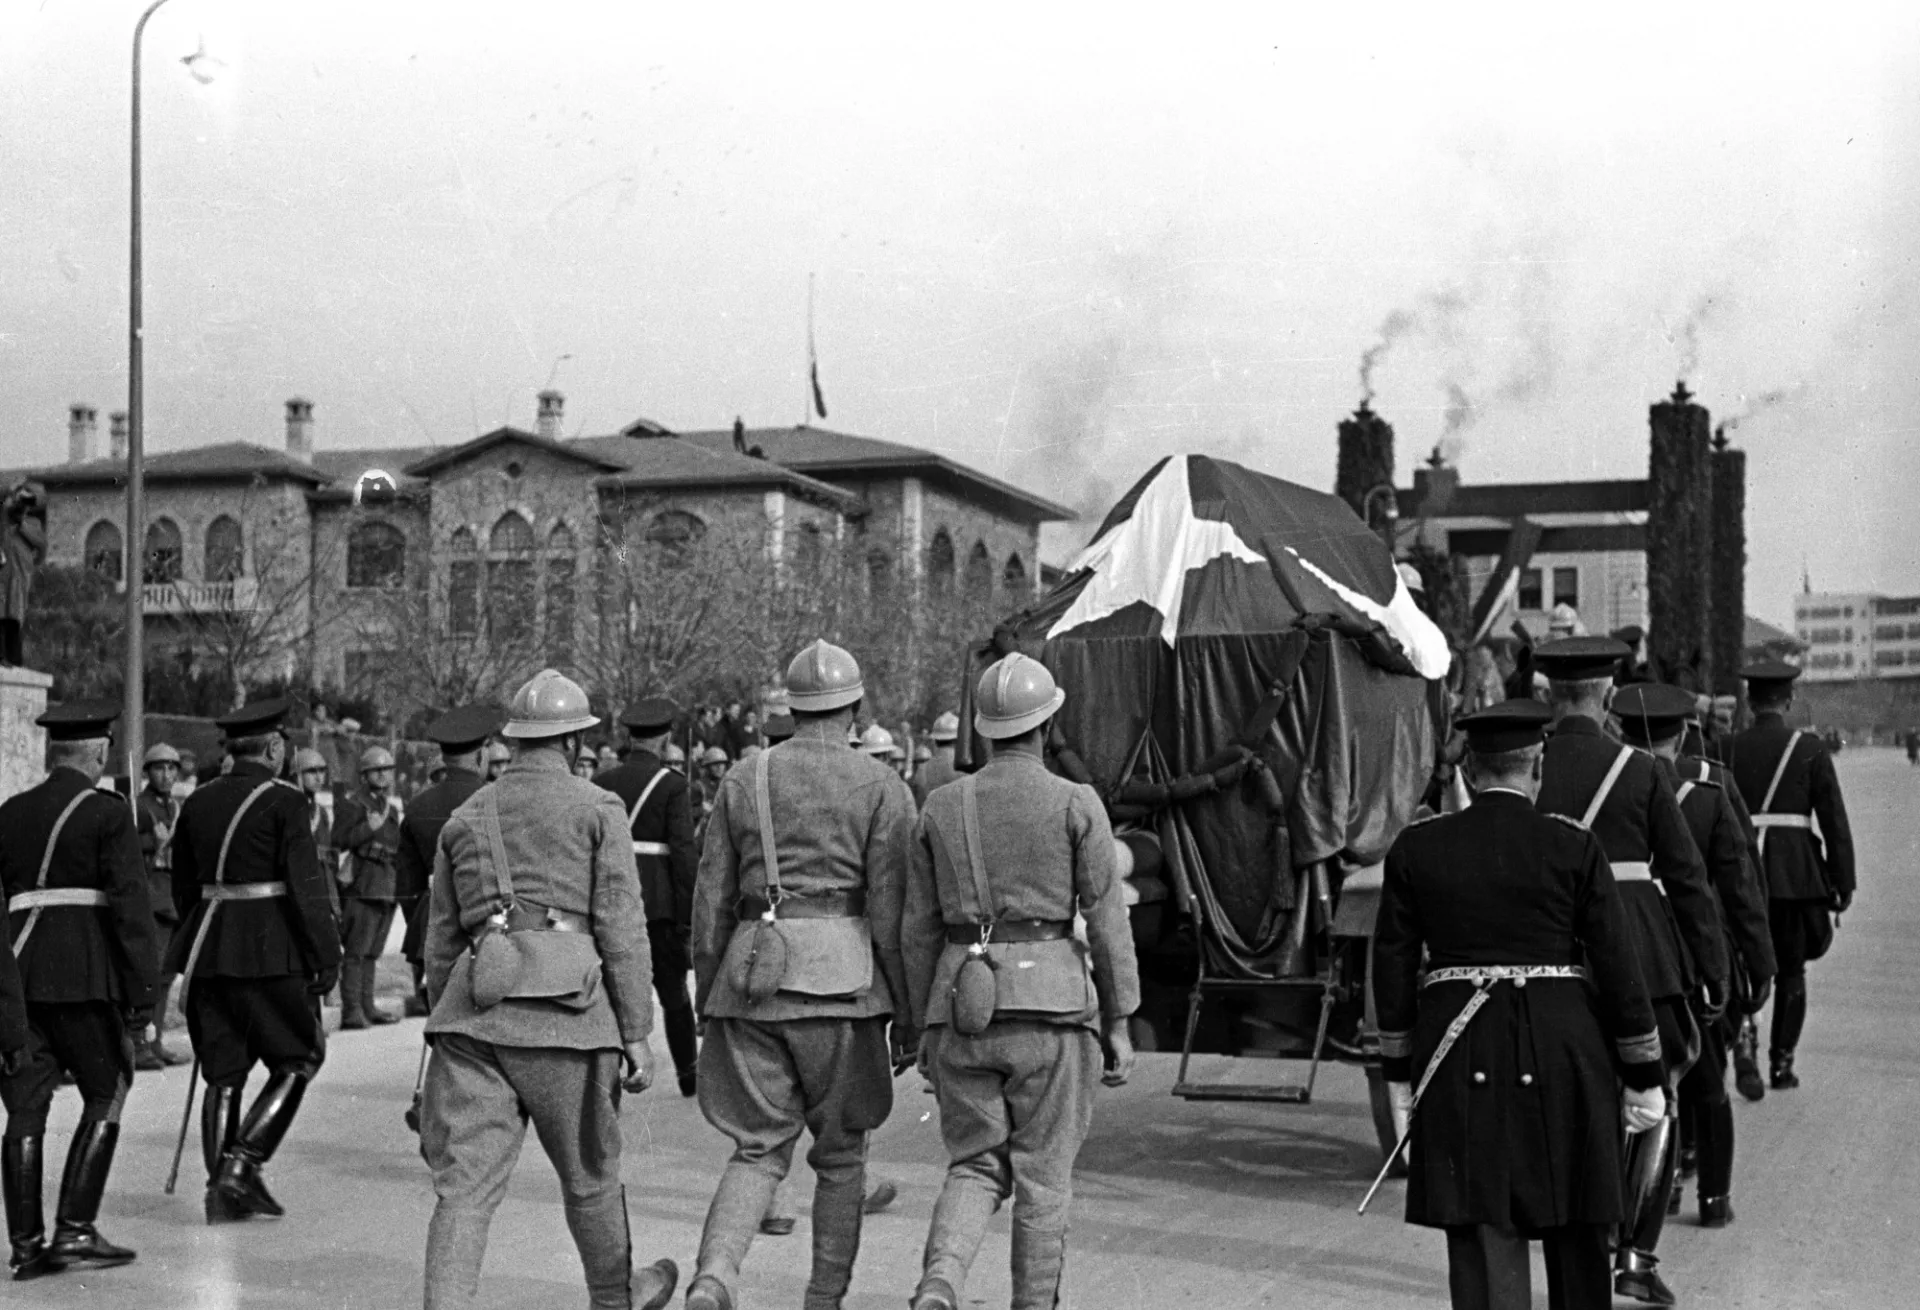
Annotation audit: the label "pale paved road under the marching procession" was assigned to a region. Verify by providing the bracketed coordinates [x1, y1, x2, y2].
[18, 749, 1920, 1310]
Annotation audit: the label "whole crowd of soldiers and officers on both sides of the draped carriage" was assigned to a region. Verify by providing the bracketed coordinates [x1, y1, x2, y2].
[0, 618, 1855, 1310]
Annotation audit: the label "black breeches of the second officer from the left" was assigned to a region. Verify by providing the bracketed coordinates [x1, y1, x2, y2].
[180, 974, 326, 1083]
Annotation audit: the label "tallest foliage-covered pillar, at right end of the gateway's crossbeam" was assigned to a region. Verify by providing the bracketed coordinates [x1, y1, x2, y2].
[1647, 382, 1715, 691]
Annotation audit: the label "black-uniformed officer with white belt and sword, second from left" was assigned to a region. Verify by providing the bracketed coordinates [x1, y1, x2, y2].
[167, 699, 340, 1224]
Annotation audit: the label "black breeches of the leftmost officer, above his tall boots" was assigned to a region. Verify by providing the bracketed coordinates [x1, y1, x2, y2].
[0, 1001, 132, 1137]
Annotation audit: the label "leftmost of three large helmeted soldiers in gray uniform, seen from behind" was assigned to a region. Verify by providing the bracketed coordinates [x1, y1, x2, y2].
[420, 668, 680, 1310]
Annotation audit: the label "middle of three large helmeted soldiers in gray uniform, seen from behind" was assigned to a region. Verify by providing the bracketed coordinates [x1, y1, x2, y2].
[687, 642, 914, 1310]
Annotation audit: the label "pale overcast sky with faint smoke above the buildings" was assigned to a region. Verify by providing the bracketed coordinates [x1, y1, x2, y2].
[0, 0, 1920, 620]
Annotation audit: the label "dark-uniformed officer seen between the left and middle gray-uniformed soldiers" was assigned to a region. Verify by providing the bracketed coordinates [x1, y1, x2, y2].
[593, 697, 701, 1097]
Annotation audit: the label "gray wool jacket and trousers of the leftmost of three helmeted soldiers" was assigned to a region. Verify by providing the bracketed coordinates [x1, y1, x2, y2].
[420, 751, 653, 1310]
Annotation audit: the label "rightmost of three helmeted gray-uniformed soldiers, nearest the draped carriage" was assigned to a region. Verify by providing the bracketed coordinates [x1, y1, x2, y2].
[900, 655, 1140, 1310]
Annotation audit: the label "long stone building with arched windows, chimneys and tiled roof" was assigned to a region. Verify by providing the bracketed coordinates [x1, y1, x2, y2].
[33, 392, 1071, 718]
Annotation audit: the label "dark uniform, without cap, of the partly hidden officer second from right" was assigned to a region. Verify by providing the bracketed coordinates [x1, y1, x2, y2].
[1672, 757, 1774, 1224]
